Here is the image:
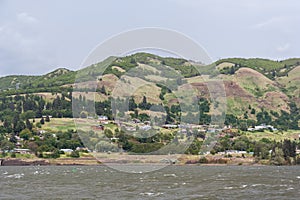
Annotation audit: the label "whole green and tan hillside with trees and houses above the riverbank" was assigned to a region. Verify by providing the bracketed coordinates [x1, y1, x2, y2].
[0, 53, 300, 160]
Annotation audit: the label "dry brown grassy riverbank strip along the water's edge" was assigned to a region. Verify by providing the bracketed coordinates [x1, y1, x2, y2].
[0, 153, 258, 166]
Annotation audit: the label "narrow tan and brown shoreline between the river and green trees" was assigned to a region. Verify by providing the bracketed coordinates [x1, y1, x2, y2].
[0, 155, 292, 167]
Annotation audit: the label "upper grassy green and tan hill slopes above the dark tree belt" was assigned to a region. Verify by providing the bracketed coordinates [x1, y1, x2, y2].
[0, 53, 300, 122]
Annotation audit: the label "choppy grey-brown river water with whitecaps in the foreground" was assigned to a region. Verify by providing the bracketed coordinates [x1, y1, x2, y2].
[0, 166, 300, 200]
